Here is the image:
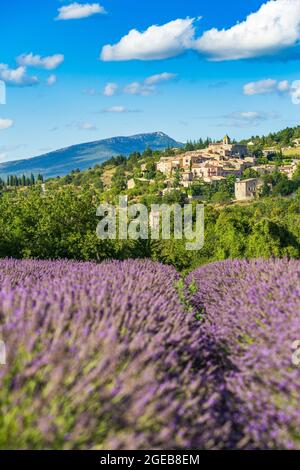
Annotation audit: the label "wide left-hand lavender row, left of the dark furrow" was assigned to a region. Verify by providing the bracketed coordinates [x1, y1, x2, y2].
[0, 260, 224, 449]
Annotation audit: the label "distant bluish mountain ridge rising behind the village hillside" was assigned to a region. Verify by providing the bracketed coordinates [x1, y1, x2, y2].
[0, 132, 183, 178]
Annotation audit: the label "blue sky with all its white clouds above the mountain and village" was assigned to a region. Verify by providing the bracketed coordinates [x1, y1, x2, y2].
[0, 0, 300, 161]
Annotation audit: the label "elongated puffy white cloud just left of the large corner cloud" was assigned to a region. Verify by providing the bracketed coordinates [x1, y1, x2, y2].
[100, 18, 195, 61]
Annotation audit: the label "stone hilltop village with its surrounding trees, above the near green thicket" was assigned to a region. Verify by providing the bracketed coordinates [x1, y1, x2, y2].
[5, 128, 300, 205]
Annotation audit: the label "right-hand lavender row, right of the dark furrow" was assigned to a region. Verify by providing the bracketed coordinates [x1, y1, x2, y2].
[187, 260, 300, 449]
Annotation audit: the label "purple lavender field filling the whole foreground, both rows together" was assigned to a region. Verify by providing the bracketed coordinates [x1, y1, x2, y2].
[0, 260, 300, 449]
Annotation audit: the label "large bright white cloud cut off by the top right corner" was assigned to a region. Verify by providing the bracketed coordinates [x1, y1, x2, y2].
[194, 0, 300, 60]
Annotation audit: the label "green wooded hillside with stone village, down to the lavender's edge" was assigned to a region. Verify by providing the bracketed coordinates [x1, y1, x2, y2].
[0, 126, 300, 271]
